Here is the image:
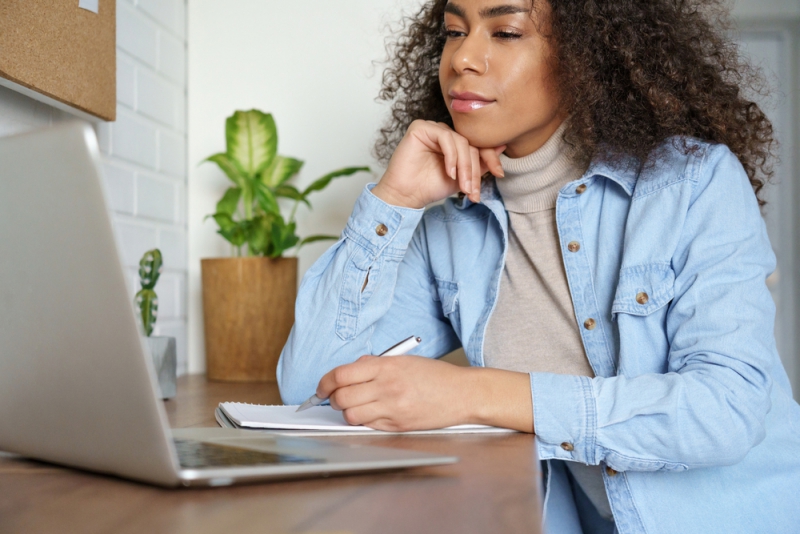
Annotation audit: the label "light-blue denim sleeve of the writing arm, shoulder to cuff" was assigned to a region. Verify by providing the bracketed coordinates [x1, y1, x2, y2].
[531, 145, 779, 471]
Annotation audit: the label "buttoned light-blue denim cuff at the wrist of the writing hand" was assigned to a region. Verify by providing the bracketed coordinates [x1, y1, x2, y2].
[530, 373, 598, 465]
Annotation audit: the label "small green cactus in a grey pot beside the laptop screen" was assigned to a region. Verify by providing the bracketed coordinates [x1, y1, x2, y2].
[135, 248, 178, 399]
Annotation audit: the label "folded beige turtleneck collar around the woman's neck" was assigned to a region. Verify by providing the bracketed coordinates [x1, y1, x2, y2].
[495, 121, 583, 213]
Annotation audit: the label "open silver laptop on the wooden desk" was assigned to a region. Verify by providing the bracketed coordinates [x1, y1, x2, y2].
[0, 122, 457, 486]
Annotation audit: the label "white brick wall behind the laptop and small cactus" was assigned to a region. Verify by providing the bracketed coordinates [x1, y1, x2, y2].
[0, 0, 187, 374]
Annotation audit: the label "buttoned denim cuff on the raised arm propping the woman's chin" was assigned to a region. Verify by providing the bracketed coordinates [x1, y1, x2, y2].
[344, 183, 425, 258]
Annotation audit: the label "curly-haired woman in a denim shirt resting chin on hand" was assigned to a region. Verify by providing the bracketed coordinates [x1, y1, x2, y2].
[278, 0, 800, 533]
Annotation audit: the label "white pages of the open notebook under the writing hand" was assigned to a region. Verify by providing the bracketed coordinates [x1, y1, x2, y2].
[219, 402, 505, 432]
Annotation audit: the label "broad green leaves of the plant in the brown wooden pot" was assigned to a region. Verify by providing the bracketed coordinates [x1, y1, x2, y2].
[204, 109, 370, 258]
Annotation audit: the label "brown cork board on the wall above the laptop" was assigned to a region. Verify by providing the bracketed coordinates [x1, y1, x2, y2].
[0, 0, 117, 121]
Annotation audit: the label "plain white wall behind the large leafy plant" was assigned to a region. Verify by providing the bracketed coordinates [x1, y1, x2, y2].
[189, 0, 419, 372]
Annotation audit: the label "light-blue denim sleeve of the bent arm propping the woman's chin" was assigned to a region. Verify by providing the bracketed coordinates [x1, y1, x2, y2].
[277, 184, 460, 404]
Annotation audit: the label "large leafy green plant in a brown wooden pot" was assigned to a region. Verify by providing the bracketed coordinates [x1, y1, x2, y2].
[201, 109, 370, 382]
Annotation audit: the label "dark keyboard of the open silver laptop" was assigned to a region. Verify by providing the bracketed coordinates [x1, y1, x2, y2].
[174, 439, 324, 469]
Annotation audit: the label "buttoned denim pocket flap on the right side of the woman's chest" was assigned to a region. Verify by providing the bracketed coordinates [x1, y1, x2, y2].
[611, 263, 675, 320]
